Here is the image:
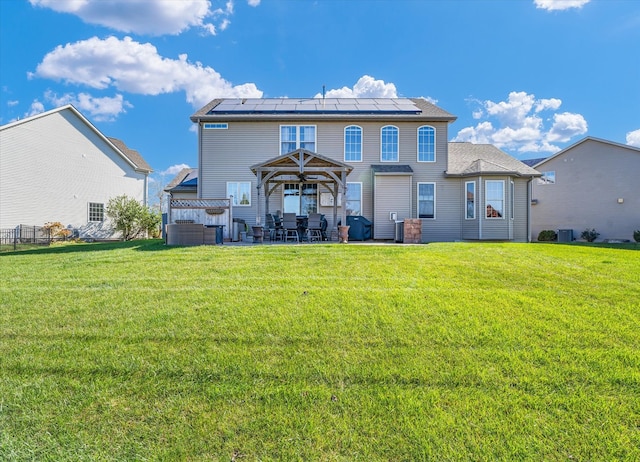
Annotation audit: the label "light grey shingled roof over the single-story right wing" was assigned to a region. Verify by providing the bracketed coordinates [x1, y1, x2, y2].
[445, 142, 540, 177]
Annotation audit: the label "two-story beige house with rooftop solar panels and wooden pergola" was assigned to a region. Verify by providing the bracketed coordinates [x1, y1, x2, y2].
[191, 98, 538, 242]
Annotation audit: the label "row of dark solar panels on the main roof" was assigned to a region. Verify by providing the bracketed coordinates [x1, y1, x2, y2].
[209, 98, 421, 114]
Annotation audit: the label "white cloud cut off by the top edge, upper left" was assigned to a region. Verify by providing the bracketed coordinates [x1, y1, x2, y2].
[29, 0, 225, 35]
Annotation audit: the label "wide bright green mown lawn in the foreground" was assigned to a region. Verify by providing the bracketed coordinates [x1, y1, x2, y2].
[0, 241, 640, 461]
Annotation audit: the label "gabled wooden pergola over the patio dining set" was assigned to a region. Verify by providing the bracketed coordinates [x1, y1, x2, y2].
[251, 149, 353, 233]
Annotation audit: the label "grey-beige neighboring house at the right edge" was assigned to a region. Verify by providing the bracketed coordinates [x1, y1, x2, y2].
[531, 137, 640, 240]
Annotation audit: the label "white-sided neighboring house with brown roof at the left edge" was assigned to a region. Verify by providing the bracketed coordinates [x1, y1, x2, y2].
[0, 105, 152, 239]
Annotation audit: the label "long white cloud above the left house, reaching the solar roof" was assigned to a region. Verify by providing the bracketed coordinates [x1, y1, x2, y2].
[29, 37, 262, 108]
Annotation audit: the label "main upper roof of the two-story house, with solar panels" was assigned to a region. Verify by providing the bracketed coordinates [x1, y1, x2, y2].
[191, 98, 456, 122]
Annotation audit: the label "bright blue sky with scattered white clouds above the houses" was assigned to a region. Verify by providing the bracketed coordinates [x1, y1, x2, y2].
[0, 0, 640, 187]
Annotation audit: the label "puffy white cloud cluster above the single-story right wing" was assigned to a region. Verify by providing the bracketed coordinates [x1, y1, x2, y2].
[454, 92, 587, 152]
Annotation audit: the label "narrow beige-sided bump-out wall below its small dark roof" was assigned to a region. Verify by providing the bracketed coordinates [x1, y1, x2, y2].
[373, 175, 412, 239]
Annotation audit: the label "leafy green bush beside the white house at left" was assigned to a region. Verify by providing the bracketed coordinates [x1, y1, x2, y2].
[106, 195, 161, 241]
